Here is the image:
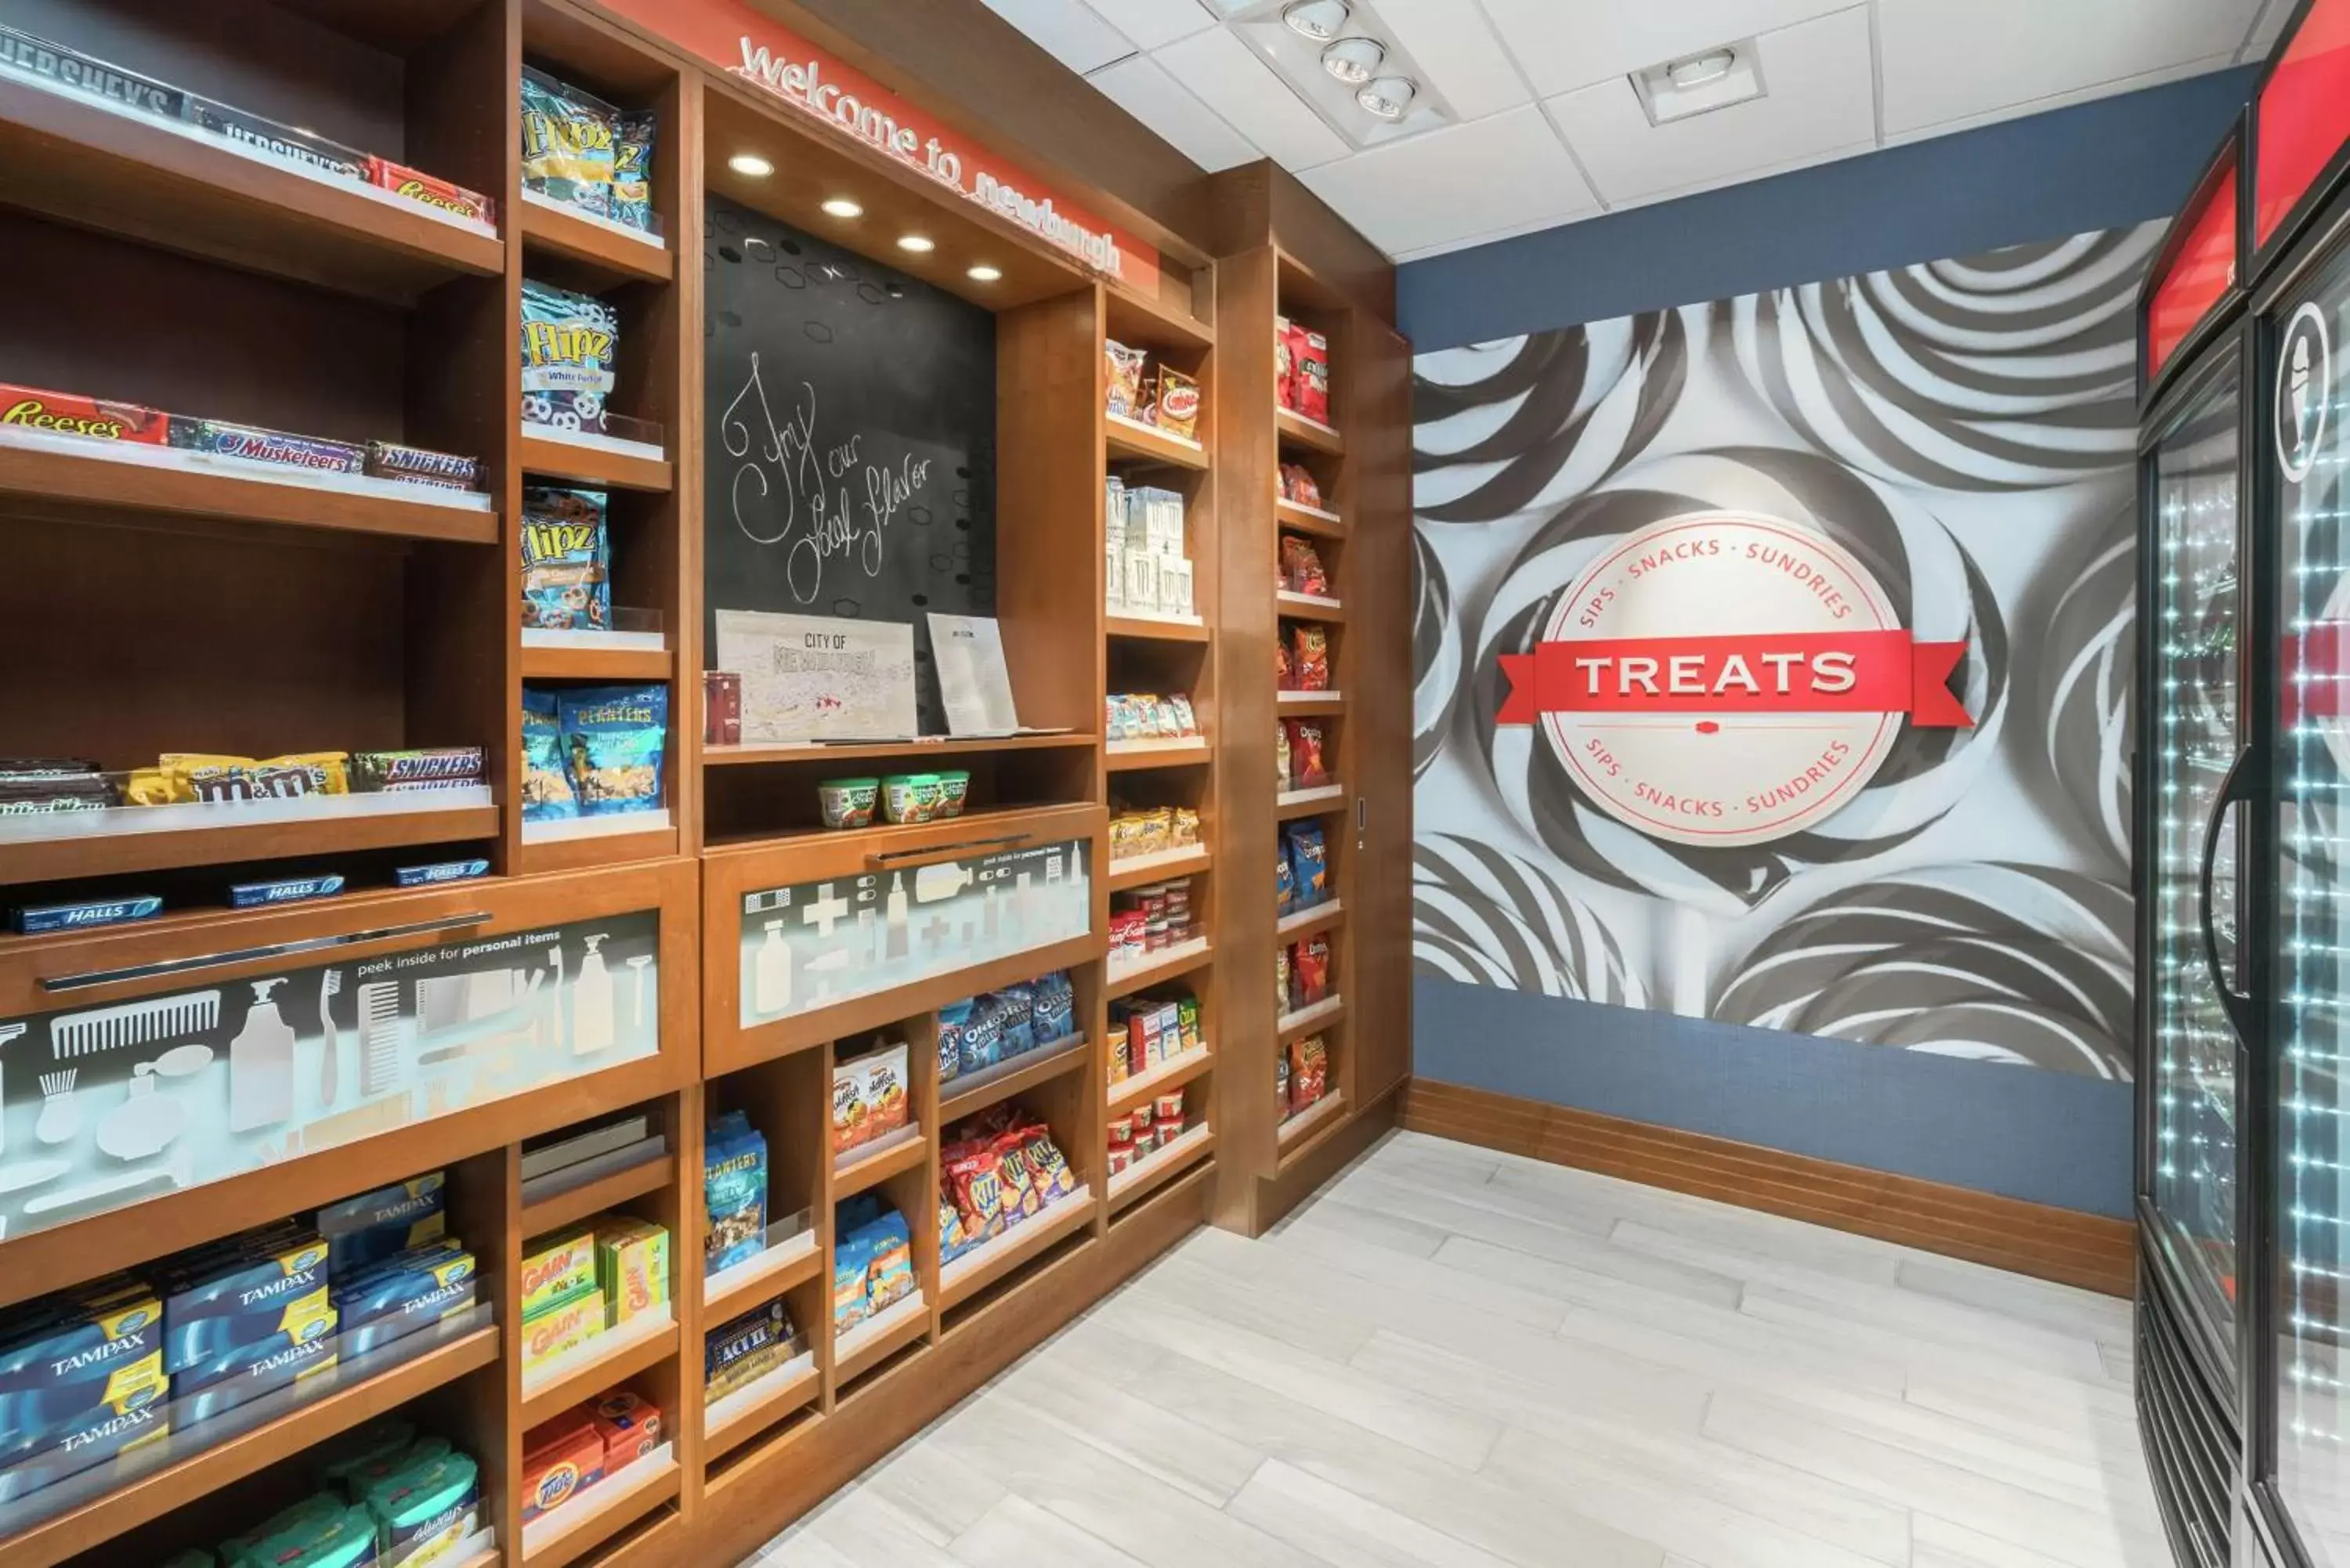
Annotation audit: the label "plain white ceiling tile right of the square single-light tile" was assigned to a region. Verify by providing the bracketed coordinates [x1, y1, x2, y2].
[1878, 0, 2261, 136]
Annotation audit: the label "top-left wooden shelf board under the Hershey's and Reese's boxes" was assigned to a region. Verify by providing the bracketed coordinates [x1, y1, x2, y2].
[0, 78, 505, 303]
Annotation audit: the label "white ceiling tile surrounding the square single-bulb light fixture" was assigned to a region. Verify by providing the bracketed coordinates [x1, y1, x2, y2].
[1544, 7, 1878, 204]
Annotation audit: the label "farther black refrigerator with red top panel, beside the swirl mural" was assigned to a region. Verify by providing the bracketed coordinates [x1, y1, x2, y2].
[2136, 120, 2261, 1568]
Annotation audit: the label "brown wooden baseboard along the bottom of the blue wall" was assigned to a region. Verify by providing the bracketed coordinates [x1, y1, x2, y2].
[1396, 1079, 2138, 1295]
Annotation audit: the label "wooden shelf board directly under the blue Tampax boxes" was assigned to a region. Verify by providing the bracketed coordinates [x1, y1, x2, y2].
[0, 1302, 498, 1568]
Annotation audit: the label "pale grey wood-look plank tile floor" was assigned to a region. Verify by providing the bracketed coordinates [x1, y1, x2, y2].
[754, 1133, 2171, 1568]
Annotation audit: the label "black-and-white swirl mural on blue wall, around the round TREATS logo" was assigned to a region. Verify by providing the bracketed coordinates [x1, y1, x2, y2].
[1412, 226, 2157, 1079]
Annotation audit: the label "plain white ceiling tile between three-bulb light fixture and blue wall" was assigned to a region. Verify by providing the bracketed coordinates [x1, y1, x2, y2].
[1300, 103, 1598, 256]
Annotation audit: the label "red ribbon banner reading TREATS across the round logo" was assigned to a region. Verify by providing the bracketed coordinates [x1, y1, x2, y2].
[1502, 632, 1974, 728]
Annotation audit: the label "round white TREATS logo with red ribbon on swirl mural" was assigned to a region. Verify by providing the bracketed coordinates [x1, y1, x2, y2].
[1499, 512, 1972, 847]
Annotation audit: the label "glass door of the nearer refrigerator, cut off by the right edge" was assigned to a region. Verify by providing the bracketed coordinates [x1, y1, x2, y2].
[2254, 236, 2350, 1568]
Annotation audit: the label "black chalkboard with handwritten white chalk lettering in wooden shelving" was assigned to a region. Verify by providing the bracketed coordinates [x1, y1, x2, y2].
[703, 195, 996, 733]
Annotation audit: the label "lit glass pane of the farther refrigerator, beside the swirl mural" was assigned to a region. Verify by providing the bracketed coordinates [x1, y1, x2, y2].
[2150, 352, 2242, 1366]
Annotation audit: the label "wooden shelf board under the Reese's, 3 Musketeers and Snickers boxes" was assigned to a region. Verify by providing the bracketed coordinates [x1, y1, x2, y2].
[0, 430, 498, 545]
